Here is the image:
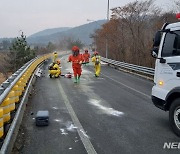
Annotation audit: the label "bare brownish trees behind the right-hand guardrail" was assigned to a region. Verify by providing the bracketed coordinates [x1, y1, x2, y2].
[93, 0, 180, 67]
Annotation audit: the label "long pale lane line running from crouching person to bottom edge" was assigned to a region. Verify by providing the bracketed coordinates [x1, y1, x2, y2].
[56, 80, 97, 154]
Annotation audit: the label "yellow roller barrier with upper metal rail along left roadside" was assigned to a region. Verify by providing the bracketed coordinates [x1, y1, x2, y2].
[0, 54, 51, 144]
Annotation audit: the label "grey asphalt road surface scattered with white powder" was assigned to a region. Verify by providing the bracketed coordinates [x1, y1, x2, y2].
[12, 53, 180, 154]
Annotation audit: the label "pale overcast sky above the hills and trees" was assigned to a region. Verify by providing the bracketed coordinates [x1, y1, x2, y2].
[0, 0, 174, 38]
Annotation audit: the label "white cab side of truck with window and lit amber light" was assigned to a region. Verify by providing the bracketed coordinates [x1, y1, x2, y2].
[155, 31, 180, 99]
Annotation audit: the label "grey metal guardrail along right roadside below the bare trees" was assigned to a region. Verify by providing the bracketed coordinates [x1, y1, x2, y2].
[101, 57, 154, 76]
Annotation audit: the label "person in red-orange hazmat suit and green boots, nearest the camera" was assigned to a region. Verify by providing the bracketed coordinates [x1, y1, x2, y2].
[68, 46, 84, 83]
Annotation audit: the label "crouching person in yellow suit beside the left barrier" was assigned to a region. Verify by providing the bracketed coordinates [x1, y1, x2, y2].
[49, 60, 61, 78]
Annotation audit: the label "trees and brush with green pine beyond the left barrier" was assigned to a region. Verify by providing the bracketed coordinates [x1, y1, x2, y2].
[0, 32, 84, 79]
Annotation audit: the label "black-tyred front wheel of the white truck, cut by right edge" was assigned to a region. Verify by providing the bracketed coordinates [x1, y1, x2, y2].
[169, 98, 180, 136]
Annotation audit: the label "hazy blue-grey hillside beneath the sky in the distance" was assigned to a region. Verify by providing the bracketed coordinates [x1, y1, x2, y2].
[27, 20, 106, 44]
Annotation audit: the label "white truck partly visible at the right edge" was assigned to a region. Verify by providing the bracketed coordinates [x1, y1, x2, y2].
[152, 14, 180, 136]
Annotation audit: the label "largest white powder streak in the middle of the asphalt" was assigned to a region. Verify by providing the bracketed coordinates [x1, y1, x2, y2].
[88, 99, 124, 117]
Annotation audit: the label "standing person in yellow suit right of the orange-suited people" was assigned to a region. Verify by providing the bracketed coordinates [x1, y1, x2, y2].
[92, 51, 101, 77]
